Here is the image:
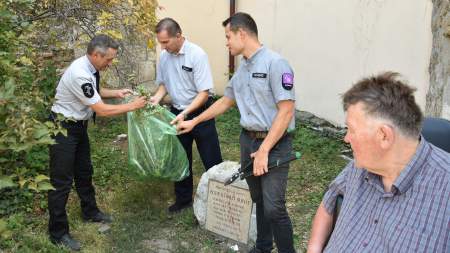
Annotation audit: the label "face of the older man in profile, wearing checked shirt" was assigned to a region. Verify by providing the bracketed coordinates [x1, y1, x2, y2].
[344, 102, 382, 171]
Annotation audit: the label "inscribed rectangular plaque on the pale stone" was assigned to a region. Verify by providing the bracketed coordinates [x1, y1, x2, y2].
[205, 180, 252, 244]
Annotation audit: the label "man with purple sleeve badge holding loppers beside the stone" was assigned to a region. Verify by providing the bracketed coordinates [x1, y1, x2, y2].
[177, 13, 295, 253]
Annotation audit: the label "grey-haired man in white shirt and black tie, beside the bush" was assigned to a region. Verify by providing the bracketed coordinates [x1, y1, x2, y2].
[48, 35, 146, 250]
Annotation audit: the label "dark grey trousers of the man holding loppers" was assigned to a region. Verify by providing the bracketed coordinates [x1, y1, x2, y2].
[240, 131, 295, 253]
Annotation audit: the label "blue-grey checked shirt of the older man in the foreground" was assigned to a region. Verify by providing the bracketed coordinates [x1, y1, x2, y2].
[323, 138, 450, 253]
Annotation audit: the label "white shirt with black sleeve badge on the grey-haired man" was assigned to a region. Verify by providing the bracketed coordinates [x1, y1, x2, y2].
[52, 55, 101, 120]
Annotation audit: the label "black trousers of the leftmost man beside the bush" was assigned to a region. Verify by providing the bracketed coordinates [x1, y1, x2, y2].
[48, 118, 99, 239]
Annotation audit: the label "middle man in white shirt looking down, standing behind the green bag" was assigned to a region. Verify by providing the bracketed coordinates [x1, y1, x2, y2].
[150, 18, 222, 213]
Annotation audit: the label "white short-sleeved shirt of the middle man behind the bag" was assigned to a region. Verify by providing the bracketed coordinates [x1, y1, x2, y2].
[156, 39, 213, 110]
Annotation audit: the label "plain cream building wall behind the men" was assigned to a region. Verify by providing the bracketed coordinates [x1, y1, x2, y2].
[159, 0, 432, 125]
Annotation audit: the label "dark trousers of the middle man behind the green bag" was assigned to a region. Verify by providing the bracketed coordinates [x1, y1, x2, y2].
[170, 97, 222, 204]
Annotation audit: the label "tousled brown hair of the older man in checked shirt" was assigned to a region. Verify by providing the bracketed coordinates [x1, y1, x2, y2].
[342, 72, 423, 138]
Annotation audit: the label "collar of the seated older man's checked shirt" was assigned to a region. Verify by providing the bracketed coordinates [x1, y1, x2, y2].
[364, 136, 431, 194]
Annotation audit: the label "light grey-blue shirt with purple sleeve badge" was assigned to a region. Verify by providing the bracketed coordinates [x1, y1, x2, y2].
[225, 47, 295, 131]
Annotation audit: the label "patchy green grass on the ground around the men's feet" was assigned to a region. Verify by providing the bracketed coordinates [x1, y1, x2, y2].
[0, 109, 345, 253]
